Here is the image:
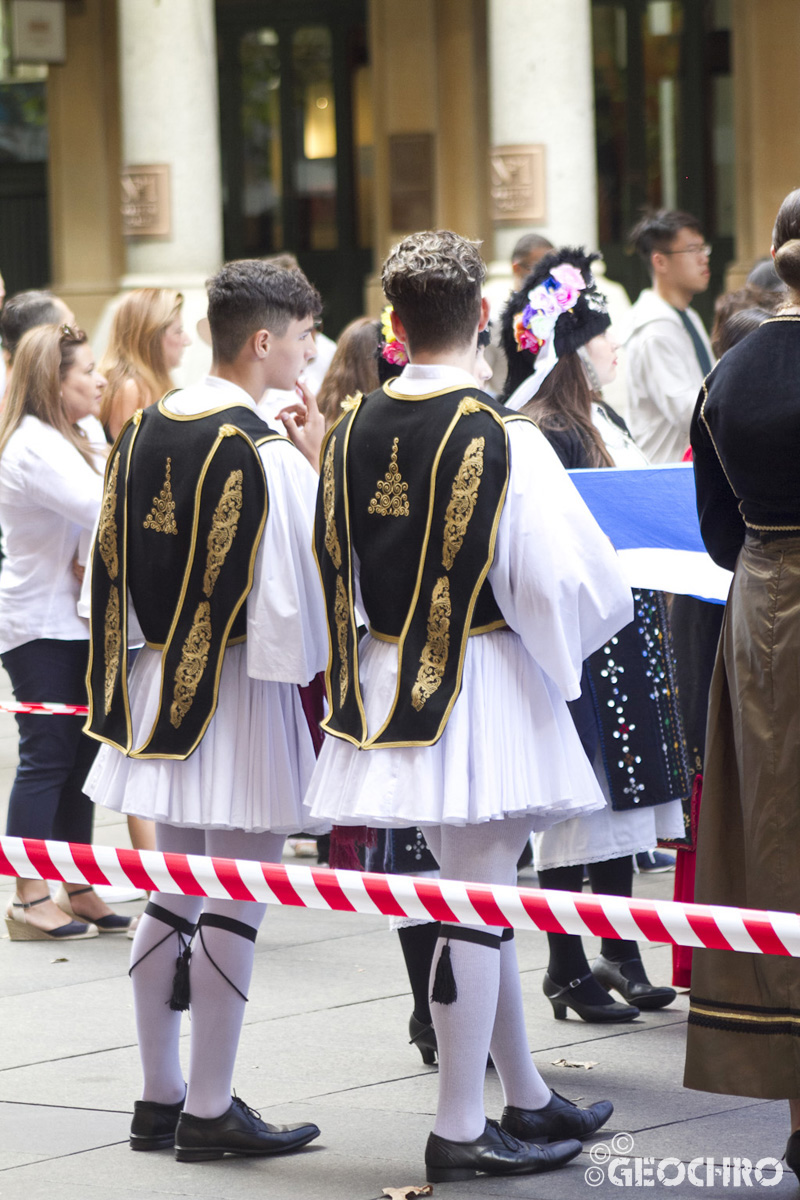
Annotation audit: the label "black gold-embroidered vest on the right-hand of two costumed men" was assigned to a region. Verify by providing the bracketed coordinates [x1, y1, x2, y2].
[314, 384, 527, 749]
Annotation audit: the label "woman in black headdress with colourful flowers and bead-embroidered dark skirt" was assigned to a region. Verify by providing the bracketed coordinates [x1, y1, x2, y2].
[503, 248, 691, 1022]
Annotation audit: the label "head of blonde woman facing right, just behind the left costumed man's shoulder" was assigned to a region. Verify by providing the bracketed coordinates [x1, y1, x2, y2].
[100, 288, 192, 442]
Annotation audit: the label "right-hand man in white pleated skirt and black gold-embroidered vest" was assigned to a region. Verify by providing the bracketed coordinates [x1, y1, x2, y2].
[306, 232, 632, 1182]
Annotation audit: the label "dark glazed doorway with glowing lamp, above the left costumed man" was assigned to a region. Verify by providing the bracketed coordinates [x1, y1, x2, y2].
[217, 0, 373, 337]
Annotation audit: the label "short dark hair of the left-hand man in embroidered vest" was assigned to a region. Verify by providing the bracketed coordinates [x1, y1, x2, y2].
[206, 258, 323, 362]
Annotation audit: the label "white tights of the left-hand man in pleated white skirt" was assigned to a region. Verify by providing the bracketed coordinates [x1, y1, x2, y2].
[131, 824, 284, 1117]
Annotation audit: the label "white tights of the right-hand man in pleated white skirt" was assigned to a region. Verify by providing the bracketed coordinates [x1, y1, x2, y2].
[425, 817, 551, 1141]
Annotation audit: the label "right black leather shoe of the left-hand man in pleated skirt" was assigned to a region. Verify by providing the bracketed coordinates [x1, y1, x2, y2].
[175, 1096, 319, 1163]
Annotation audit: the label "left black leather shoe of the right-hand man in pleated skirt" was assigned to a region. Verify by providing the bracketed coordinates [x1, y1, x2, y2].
[425, 1121, 583, 1183]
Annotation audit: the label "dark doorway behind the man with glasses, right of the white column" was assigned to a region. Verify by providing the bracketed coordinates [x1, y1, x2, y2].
[593, 0, 734, 322]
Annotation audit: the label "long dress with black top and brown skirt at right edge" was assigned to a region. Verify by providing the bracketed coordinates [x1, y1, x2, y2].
[684, 317, 800, 1099]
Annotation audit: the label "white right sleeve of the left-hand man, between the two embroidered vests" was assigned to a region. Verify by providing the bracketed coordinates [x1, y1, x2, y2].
[247, 440, 327, 684]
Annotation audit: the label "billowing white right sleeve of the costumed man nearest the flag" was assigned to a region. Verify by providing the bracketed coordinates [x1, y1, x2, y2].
[488, 421, 633, 700]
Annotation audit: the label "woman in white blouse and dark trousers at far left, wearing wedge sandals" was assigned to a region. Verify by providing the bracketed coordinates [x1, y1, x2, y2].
[0, 325, 131, 941]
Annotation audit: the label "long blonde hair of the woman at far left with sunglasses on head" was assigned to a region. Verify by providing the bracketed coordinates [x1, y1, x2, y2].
[0, 325, 100, 474]
